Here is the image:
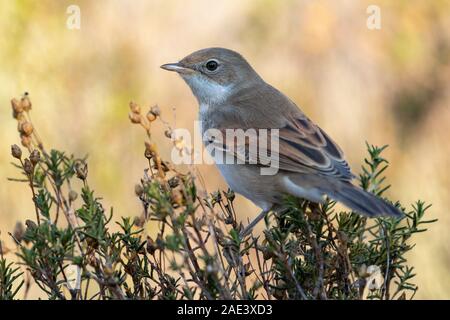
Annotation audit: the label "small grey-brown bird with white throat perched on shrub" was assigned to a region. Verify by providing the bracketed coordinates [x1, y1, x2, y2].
[161, 47, 403, 235]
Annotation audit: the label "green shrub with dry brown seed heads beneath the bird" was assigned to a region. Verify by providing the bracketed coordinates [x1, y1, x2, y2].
[0, 94, 435, 300]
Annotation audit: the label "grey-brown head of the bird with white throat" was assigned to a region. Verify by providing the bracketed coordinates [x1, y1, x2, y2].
[161, 48, 262, 105]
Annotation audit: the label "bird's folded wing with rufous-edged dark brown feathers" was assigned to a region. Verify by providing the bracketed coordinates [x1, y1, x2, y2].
[205, 106, 354, 181]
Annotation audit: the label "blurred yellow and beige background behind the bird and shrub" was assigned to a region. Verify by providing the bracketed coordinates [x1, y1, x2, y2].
[0, 0, 450, 299]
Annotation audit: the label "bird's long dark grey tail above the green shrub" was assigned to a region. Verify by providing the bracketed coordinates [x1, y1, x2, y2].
[323, 182, 403, 217]
